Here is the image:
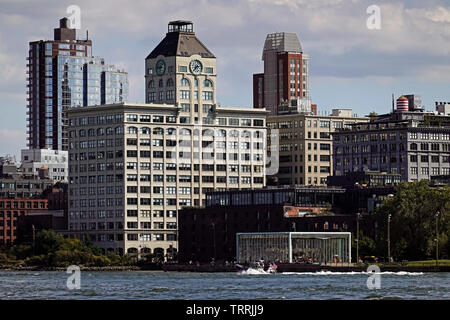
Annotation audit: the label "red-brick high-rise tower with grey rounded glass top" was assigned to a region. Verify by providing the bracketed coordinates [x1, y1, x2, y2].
[253, 32, 309, 115]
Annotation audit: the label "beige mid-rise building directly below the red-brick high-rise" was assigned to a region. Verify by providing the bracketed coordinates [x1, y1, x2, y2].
[267, 109, 369, 186]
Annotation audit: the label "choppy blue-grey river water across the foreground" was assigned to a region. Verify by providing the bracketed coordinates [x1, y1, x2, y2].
[0, 271, 450, 300]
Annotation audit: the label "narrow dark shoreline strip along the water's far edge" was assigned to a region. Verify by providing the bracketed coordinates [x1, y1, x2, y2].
[0, 264, 450, 273]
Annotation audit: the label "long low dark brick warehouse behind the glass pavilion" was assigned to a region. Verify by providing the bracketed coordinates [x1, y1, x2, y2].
[178, 186, 395, 263]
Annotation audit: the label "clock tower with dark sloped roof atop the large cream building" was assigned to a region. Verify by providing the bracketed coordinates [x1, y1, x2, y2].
[145, 20, 216, 124]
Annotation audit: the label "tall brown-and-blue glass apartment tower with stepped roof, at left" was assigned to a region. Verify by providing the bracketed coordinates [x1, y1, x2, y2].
[27, 18, 128, 150]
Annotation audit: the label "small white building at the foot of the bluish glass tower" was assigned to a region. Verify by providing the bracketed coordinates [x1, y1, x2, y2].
[20, 149, 69, 183]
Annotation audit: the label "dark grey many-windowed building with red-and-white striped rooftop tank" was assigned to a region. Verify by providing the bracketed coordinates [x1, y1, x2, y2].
[333, 96, 450, 182]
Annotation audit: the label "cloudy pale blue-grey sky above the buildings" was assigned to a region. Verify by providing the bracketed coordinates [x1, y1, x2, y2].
[0, 0, 450, 158]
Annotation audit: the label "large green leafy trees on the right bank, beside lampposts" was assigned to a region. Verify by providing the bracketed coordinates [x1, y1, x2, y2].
[376, 180, 450, 260]
